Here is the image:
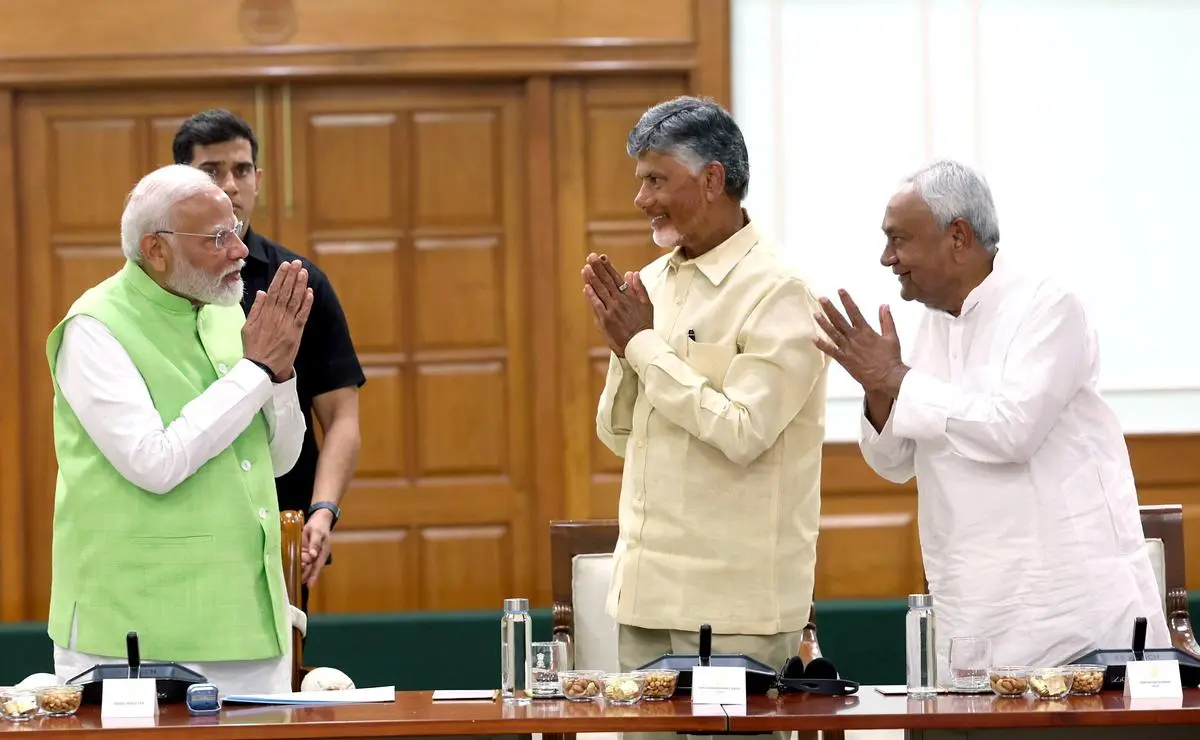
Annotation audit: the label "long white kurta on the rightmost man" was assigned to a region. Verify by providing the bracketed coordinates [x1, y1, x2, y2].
[860, 257, 1170, 676]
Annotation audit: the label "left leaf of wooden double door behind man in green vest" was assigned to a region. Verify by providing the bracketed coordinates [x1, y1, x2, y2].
[16, 88, 265, 619]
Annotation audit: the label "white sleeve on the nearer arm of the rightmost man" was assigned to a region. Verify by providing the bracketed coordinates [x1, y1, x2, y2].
[888, 285, 1090, 463]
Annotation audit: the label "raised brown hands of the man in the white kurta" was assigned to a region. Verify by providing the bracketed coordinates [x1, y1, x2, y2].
[812, 290, 908, 398]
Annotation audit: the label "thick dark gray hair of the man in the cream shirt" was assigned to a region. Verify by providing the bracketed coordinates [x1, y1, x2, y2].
[625, 96, 750, 200]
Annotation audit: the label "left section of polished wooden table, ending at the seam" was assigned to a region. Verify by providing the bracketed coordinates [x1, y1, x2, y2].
[0, 691, 727, 740]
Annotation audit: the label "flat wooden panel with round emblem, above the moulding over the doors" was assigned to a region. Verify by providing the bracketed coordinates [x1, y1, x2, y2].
[0, 0, 696, 59]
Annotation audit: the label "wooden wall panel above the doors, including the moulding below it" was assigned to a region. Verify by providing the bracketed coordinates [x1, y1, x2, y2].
[0, 0, 730, 86]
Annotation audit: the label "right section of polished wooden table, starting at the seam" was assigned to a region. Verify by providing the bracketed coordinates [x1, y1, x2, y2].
[726, 686, 1200, 736]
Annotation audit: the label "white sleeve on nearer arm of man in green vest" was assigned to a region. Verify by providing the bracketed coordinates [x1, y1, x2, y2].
[55, 315, 271, 494]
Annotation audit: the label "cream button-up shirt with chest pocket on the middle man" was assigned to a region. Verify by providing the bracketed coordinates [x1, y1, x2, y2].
[596, 218, 827, 634]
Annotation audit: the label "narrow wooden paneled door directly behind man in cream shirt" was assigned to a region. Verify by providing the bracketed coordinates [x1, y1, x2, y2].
[554, 76, 688, 519]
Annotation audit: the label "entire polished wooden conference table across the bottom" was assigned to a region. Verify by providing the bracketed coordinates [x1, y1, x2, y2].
[0, 686, 1200, 740]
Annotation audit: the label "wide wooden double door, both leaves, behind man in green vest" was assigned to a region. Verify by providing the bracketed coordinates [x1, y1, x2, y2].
[17, 80, 535, 619]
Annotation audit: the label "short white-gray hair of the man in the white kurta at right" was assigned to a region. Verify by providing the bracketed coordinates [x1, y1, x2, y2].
[904, 160, 1000, 254]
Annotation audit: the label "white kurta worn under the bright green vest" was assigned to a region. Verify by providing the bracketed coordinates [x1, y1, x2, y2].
[54, 315, 305, 694]
